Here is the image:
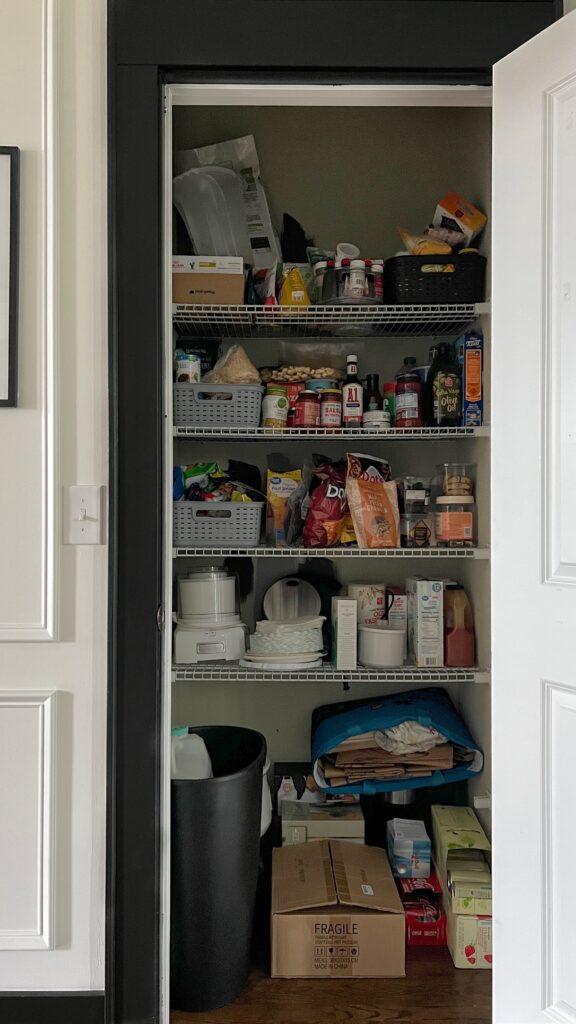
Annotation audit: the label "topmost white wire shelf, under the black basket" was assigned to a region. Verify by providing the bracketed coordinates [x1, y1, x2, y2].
[172, 302, 490, 338]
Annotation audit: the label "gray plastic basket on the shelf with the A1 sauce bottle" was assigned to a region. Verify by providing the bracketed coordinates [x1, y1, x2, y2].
[174, 384, 263, 427]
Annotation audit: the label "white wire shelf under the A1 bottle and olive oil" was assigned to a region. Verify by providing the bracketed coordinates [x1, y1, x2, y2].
[173, 427, 490, 441]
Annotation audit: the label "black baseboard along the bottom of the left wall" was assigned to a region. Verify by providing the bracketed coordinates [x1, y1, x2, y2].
[0, 992, 105, 1024]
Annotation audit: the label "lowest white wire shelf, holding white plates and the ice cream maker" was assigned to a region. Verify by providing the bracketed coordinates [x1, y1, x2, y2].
[172, 662, 490, 686]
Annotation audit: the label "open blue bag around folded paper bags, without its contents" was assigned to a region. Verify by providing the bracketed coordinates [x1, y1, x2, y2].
[312, 687, 484, 795]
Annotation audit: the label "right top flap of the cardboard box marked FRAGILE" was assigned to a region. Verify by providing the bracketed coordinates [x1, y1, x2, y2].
[330, 840, 404, 913]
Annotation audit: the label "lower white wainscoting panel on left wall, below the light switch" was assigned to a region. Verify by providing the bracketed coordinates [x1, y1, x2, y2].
[0, 691, 56, 950]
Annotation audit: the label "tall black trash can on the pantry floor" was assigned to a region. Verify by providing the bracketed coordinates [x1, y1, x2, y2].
[170, 725, 266, 1012]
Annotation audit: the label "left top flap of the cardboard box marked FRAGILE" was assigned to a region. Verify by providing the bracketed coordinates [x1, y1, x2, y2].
[272, 840, 338, 913]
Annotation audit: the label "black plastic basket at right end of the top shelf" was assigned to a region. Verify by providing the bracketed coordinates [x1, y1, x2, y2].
[383, 253, 486, 305]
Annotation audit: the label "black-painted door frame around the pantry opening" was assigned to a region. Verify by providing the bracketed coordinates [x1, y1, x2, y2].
[103, 0, 562, 1024]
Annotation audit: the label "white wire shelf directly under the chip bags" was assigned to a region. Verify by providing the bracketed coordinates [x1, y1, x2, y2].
[172, 547, 490, 561]
